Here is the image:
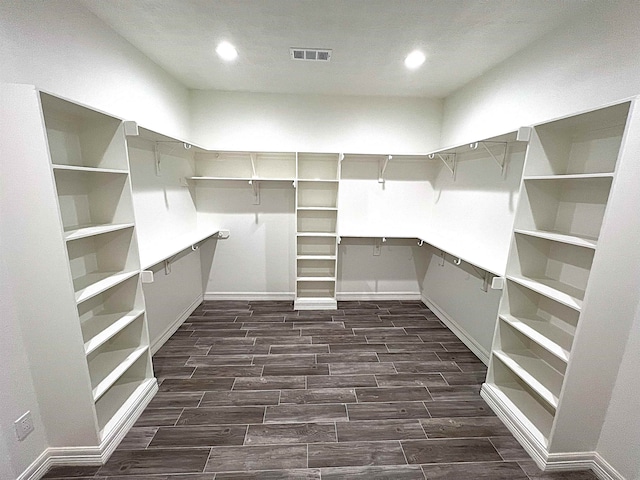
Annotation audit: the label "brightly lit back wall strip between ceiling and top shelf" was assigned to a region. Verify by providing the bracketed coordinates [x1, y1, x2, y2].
[191, 90, 442, 154]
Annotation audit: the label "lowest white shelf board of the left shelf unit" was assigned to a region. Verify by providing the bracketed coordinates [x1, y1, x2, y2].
[98, 378, 157, 440]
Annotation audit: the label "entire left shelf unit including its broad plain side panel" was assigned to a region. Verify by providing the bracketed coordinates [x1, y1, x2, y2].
[3, 85, 157, 463]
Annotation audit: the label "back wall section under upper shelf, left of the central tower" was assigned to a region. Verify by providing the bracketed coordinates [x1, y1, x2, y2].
[196, 182, 295, 300]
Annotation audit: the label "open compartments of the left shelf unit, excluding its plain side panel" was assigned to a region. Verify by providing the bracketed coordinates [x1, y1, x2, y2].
[40, 93, 157, 449]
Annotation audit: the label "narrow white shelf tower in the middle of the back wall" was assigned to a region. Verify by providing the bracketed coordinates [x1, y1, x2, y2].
[294, 153, 340, 310]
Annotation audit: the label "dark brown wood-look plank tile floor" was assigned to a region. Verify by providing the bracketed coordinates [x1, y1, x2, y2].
[45, 301, 596, 480]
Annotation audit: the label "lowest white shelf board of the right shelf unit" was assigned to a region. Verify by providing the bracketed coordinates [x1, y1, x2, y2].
[483, 383, 553, 448]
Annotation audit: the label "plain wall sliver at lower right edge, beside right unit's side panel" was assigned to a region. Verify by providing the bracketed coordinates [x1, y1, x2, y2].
[598, 304, 640, 480]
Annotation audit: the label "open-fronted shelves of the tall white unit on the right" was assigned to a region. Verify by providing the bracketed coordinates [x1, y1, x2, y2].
[482, 102, 631, 468]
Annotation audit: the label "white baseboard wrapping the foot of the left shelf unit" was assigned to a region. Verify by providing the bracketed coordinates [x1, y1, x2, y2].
[22, 379, 158, 480]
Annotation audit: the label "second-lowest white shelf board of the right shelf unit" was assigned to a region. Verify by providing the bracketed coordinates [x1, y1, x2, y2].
[493, 350, 564, 410]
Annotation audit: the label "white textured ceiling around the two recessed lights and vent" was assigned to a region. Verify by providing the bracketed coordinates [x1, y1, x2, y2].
[79, 0, 606, 97]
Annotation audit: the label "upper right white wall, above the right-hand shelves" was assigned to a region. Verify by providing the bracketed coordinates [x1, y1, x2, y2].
[441, 0, 640, 145]
